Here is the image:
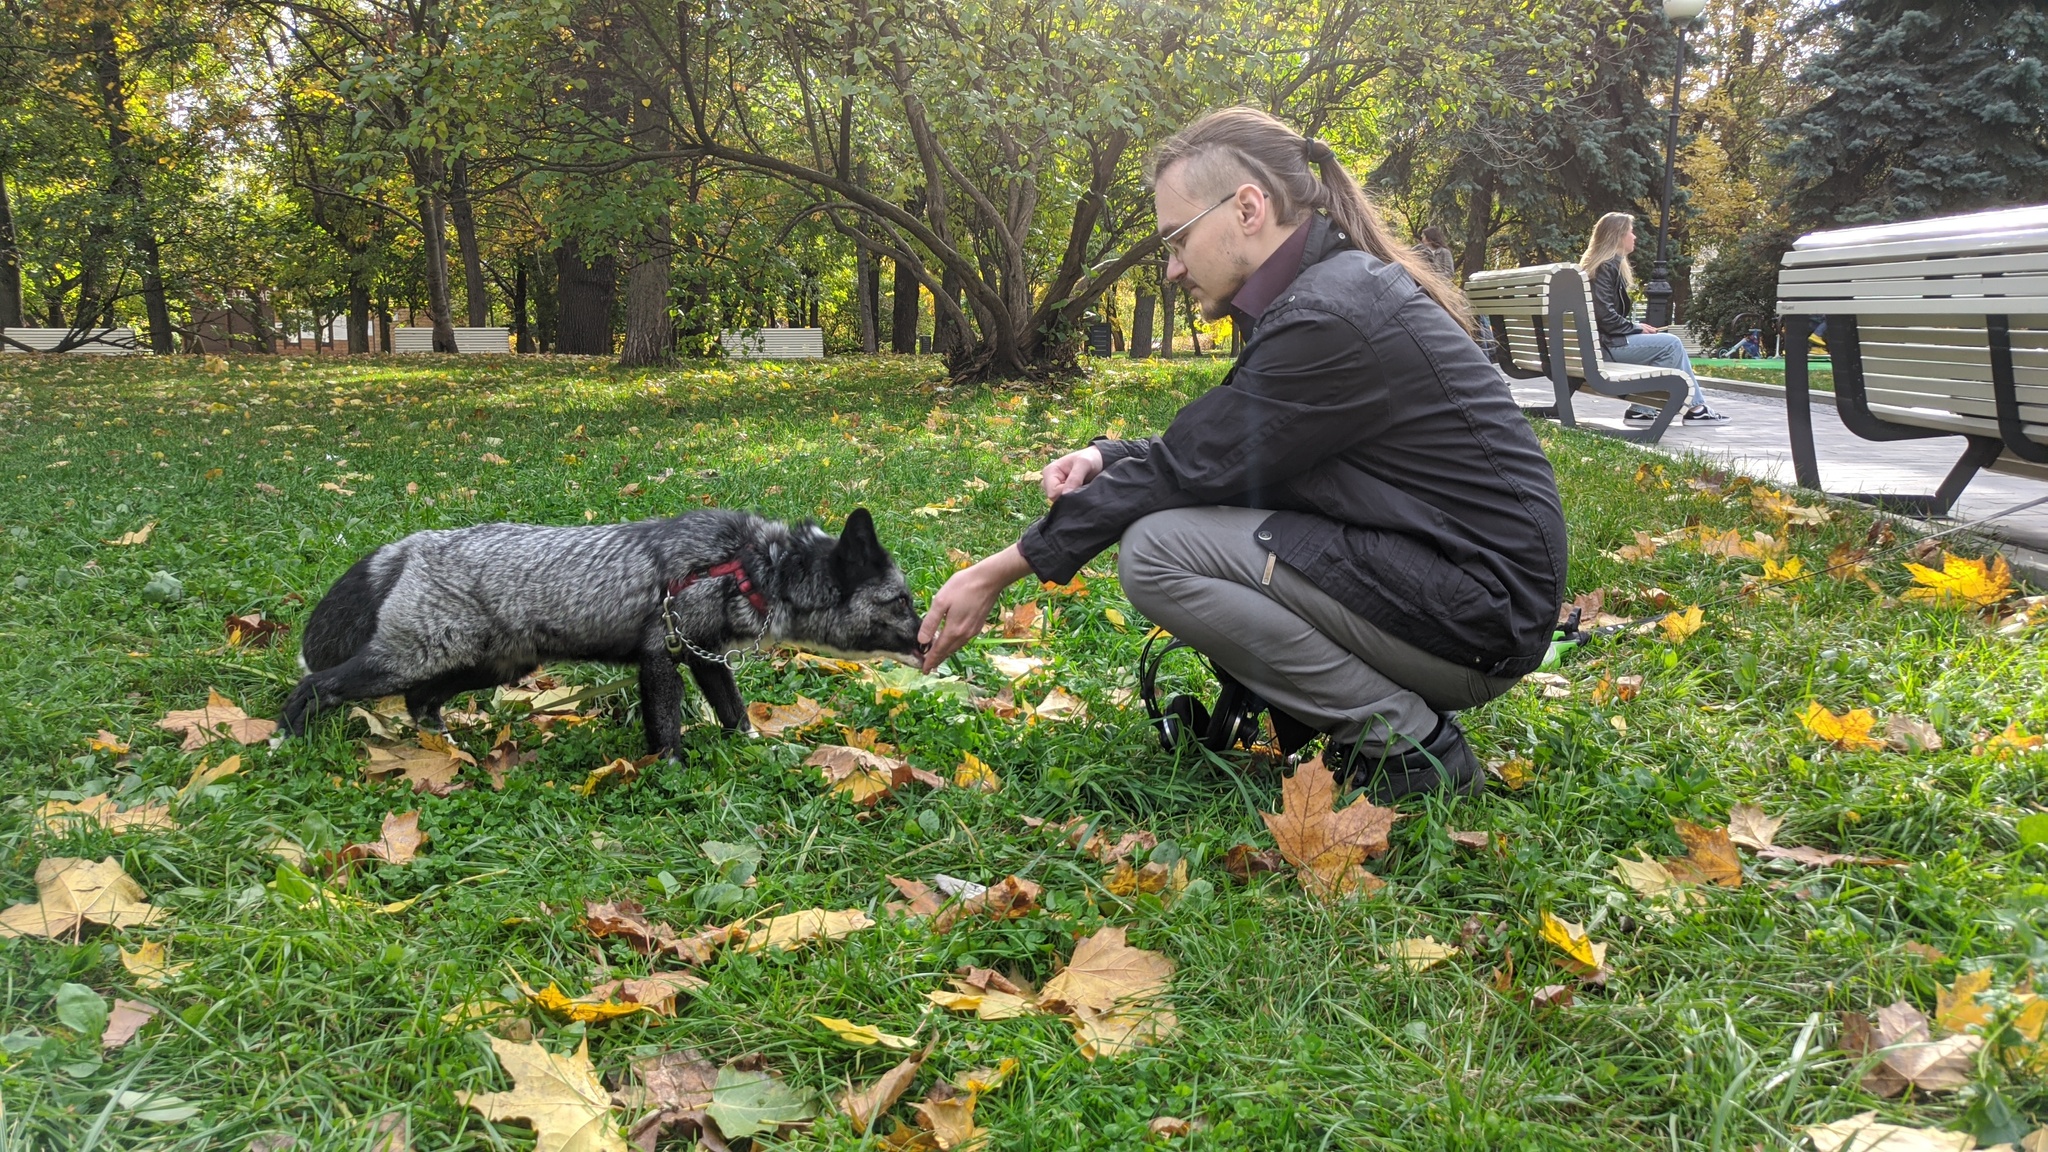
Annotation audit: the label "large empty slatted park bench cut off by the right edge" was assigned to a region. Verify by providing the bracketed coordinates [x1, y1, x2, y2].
[1778, 205, 2048, 517]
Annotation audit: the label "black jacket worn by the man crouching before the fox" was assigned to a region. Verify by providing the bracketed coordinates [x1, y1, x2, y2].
[1018, 215, 1565, 676]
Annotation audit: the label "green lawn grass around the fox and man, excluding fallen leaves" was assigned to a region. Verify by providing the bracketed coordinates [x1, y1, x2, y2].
[0, 357, 2048, 1150]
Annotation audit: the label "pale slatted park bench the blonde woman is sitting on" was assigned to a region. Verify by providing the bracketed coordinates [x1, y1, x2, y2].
[1464, 264, 1692, 445]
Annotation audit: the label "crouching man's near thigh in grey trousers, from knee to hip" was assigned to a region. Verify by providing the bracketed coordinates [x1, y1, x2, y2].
[1118, 506, 1516, 711]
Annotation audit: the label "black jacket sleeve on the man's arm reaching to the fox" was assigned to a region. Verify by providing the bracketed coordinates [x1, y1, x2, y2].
[1018, 310, 1386, 584]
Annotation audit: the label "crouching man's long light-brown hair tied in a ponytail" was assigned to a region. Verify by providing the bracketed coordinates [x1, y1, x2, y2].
[1145, 107, 1473, 332]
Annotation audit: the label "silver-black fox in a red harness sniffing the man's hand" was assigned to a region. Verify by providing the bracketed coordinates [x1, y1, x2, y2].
[281, 508, 920, 756]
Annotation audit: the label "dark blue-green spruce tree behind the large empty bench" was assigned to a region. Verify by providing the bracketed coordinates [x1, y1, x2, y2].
[1778, 0, 2048, 230]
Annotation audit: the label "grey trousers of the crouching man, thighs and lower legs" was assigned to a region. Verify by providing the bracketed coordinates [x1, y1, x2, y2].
[1118, 506, 1520, 752]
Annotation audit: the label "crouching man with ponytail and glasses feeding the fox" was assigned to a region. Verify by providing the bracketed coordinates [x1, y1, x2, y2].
[918, 109, 1567, 801]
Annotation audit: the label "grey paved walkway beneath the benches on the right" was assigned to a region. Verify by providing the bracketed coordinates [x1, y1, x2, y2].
[1513, 377, 2048, 584]
